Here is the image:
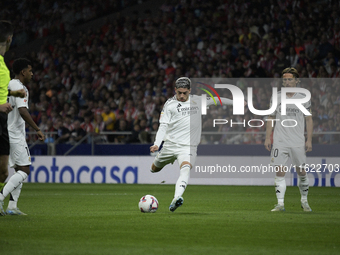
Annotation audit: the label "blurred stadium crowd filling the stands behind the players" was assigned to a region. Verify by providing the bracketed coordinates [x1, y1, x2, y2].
[0, 0, 340, 144]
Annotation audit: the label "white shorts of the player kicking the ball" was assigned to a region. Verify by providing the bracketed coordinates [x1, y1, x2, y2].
[153, 141, 197, 168]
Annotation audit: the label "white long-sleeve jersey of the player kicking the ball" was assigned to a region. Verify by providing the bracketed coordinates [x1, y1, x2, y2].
[154, 95, 233, 147]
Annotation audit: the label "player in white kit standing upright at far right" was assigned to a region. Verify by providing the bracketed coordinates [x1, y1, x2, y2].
[264, 67, 313, 212]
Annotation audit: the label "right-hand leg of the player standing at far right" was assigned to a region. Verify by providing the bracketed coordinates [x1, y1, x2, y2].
[291, 147, 312, 212]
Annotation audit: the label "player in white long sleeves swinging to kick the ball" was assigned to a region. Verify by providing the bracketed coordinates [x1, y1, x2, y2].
[150, 77, 233, 212]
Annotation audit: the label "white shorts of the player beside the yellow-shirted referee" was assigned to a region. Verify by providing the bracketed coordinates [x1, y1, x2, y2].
[8, 141, 31, 168]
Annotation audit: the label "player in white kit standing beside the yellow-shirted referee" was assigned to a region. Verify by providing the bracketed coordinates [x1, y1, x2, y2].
[0, 58, 45, 215]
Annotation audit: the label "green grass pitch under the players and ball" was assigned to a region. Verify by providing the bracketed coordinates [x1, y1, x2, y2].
[0, 184, 340, 255]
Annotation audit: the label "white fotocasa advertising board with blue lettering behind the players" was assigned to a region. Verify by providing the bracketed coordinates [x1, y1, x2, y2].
[9, 156, 340, 187]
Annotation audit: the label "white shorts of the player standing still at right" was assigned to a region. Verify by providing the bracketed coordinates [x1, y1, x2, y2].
[270, 145, 306, 167]
